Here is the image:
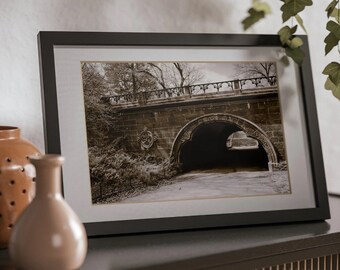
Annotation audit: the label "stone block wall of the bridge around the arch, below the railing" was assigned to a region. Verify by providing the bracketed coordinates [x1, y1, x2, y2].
[116, 94, 286, 161]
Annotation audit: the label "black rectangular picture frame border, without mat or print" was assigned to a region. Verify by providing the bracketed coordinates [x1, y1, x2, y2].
[38, 32, 330, 236]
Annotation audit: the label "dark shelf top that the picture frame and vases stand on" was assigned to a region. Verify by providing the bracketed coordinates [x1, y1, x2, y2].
[0, 196, 340, 270]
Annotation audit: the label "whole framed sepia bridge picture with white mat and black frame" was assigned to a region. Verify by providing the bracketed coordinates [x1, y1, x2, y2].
[38, 32, 330, 235]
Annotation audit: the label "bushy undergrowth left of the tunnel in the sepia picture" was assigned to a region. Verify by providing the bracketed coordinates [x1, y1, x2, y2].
[88, 140, 177, 203]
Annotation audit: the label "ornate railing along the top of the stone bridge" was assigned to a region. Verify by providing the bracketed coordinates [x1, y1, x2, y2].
[101, 76, 277, 105]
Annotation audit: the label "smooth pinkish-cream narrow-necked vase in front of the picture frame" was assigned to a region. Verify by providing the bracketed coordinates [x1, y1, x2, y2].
[9, 155, 87, 270]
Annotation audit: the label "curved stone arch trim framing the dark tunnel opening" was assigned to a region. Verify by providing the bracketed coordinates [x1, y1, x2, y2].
[170, 113, 278, 171]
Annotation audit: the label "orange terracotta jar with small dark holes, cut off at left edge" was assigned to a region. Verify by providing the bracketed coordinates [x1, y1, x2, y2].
[0, 126, 39, 248]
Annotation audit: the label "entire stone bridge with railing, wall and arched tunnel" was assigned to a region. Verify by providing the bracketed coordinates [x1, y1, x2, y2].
[102, 77, 286, 170]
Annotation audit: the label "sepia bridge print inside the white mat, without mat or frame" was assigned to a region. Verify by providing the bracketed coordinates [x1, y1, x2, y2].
[81, 61, 292, 204]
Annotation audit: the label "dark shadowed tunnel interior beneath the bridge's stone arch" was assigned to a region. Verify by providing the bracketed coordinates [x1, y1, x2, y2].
[180, 122, 268, 172]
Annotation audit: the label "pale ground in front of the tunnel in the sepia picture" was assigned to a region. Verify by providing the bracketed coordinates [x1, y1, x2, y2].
[121, 171, 290, 203]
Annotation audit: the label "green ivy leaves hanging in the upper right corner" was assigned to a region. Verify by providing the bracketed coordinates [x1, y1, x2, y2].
[242, 0, 340, 99]
